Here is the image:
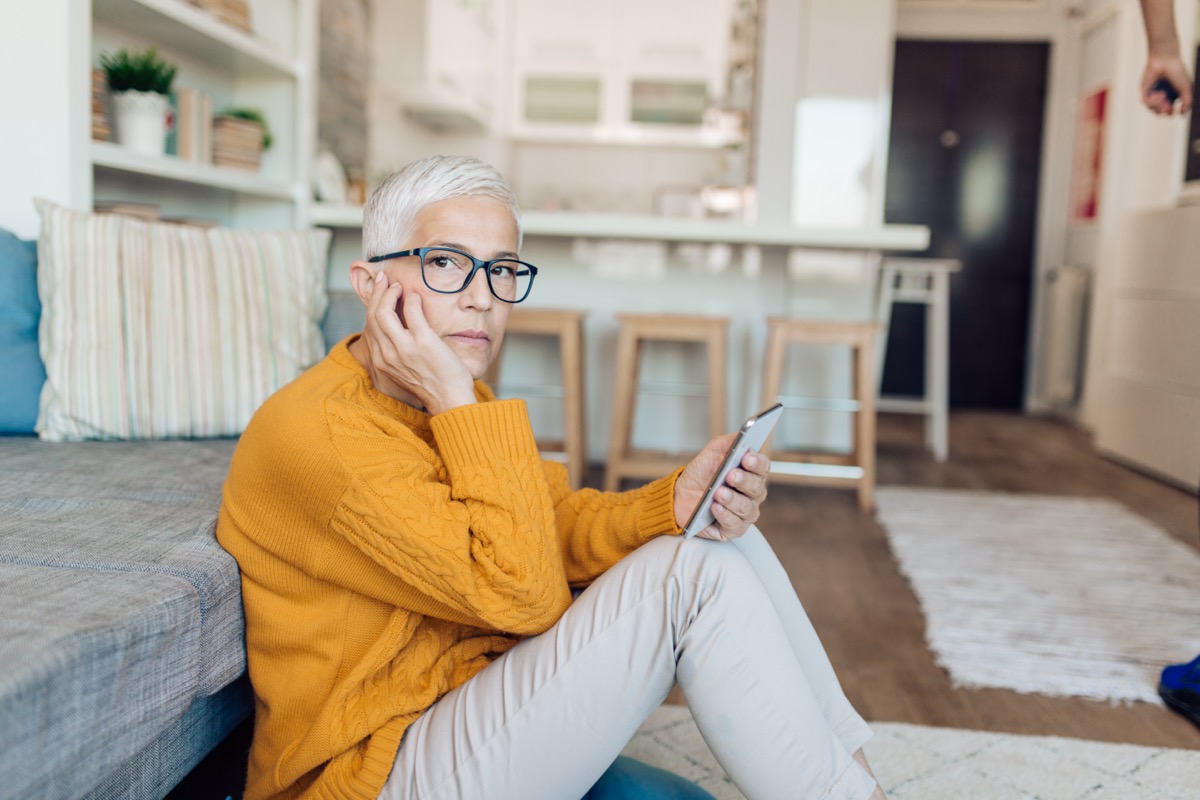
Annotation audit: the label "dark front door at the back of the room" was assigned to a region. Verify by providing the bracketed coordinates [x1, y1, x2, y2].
[883, 41, 1049, 409]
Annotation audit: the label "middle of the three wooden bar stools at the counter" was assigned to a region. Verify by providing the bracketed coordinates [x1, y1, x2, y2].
[604, 313, 730, 492]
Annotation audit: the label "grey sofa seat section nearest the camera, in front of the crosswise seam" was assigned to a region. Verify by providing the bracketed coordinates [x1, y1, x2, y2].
[0, 564, 199, 799]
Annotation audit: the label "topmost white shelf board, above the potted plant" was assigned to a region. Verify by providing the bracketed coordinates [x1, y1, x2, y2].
[92, 0, 300, 78]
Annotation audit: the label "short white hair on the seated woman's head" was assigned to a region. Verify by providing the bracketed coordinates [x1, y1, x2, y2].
[362, 156, 521, 258]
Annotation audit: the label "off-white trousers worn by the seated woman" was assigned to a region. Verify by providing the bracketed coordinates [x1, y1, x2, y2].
[380, 527, 875, 800]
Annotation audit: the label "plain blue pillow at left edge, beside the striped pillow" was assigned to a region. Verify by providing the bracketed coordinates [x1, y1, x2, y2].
[0, 229, 46, 435]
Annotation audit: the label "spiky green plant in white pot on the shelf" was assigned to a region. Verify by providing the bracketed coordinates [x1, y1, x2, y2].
[100, 47, 175, 155]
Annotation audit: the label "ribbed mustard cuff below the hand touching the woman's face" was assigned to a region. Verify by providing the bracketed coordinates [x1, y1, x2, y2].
[430, 399, 541, 469]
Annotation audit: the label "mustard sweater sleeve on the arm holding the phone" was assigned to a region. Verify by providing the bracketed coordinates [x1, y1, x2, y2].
[546, 462, 683, 587]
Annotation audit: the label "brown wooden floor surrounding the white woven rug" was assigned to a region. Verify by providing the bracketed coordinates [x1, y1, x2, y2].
[657, 413, 1200, 750]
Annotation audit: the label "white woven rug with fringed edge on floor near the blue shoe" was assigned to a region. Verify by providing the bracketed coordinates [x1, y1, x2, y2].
[876, 487, 1200, 703]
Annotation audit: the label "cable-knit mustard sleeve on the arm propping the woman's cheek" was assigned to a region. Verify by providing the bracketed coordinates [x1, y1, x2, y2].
[325, 401, 570, 636]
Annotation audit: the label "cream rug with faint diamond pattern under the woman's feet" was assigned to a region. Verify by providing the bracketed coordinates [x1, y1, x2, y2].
[625, 705, 1200, 800]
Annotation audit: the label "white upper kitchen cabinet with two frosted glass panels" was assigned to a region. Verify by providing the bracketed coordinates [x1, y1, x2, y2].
[511, 0, 740, 146]
